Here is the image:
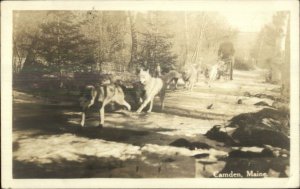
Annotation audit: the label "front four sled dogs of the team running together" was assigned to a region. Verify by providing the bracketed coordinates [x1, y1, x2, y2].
[79, 66, 197, 127]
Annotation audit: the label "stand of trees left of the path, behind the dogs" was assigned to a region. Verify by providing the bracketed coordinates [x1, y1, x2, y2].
[13, 11, 237, 73]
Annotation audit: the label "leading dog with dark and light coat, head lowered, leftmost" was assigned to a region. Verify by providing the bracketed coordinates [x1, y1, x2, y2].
[80, 78, 131, 127]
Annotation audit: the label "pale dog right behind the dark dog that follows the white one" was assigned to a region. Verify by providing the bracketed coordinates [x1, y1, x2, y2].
[182, 65, 198, 91]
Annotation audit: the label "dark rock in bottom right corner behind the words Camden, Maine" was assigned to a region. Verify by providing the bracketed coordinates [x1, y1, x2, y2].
[214, 145, 289, 178]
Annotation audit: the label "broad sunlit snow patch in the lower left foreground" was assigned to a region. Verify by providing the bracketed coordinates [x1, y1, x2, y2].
[14, 134, 141, 164]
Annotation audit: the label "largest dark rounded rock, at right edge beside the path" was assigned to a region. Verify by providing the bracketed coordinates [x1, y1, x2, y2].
[206, 108, 290, 149]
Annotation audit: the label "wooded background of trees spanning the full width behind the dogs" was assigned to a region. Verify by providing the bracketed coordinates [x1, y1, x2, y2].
[13, 10, 289, 93]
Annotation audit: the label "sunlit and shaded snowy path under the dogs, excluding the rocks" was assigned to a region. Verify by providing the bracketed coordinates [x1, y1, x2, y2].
[13, 69, 278, 178]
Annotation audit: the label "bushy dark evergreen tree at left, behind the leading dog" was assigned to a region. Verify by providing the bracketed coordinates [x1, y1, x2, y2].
[38, 11, 95, 73]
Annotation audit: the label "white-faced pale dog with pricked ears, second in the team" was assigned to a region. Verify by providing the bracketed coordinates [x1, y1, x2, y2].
[136, 69, 165, 113]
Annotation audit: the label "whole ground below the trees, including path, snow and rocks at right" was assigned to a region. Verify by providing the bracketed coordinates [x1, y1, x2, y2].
[13, 70, 290, 178]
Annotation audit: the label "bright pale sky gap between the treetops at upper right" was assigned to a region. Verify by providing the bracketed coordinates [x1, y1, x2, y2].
[220, 11, 274, 32]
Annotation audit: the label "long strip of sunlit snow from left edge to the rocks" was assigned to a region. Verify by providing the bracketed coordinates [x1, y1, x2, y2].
[14, 131, 227, 164]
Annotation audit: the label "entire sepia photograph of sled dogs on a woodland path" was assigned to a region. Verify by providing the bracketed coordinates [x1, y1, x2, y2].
[1, 1, 299, 187]
